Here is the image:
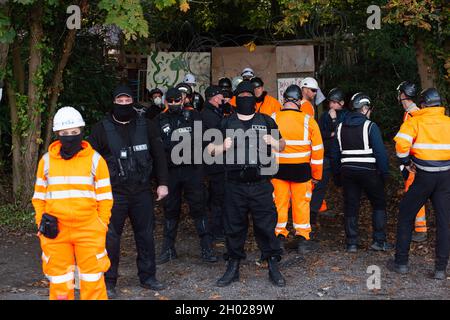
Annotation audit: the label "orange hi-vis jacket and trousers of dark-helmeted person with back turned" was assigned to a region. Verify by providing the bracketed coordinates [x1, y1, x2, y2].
[272, 109, 324, 240]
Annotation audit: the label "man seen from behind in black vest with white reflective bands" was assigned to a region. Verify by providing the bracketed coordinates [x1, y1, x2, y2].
[331, 92, 393, 252]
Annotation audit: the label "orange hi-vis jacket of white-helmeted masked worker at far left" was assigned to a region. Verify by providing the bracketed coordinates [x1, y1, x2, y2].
[32, 140, 113, 226]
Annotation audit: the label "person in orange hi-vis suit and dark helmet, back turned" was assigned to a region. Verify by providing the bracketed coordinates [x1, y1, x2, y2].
[272, 85, 324, 253]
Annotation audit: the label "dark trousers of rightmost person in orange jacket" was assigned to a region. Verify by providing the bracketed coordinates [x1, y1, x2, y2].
[395, 170, 450, 271]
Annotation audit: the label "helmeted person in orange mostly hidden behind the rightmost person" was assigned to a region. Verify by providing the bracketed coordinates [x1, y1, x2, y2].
[397, 81, 427, 242]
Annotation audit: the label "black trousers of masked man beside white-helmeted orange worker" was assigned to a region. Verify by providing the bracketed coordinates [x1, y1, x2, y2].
[105, 191, 156, 285]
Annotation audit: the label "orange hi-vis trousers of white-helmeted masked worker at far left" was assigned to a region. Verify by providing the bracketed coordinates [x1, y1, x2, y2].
[39, 217, 110, 300]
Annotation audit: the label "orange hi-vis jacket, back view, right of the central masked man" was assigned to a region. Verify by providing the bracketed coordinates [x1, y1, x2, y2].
[272, 109, 324, 180]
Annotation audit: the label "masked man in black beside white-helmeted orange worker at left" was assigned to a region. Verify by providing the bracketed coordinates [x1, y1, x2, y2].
[88, 86, 168, 298]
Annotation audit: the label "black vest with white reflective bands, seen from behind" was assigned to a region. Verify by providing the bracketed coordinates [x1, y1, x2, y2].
[337, 120, 376, 169]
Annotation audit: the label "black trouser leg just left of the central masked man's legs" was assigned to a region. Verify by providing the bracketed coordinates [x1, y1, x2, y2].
[208, 172, 225, 238]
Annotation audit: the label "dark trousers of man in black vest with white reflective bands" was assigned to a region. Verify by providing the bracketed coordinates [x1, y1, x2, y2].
[341, 168, 386, 245]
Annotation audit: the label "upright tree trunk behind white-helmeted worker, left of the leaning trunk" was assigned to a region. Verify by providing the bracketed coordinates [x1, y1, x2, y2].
[22, 1, 44, 200]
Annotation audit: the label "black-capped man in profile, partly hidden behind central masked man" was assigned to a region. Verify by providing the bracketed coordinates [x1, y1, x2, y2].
[202, 86, 226, 241]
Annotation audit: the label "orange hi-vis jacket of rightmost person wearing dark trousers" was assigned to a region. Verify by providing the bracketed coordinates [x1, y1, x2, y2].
[394, 107, 450, 172]
